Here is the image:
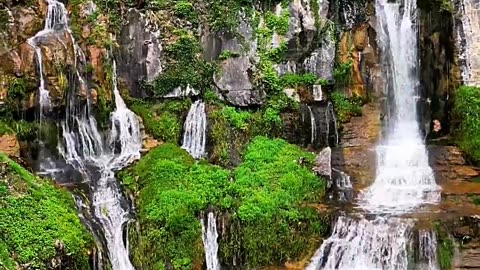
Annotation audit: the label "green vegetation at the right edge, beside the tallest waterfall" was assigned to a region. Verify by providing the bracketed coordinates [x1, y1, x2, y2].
[455, 86, 480, 163]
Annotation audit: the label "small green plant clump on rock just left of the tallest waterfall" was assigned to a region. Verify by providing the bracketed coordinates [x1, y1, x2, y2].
[330, 91, 363, 123]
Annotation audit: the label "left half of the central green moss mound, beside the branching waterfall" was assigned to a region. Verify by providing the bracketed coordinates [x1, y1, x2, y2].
[123, 144, 230, 269]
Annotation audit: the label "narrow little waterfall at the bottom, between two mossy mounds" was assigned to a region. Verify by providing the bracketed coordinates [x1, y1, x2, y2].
[202, 212, 220, 270]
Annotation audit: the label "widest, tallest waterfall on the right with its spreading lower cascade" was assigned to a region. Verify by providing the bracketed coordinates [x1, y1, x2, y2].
[307, 0, 440, 270]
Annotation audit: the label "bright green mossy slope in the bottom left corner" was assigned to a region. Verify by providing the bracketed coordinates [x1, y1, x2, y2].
[0, 154, 92, 269]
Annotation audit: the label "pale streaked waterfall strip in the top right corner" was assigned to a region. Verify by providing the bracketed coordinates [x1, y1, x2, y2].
[456, 0, 480, 86]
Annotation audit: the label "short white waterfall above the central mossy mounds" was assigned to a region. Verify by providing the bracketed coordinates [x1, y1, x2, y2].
[182, 100, 207, 159]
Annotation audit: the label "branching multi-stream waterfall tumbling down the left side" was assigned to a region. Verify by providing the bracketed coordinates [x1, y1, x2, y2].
[29, 0, 141, 270]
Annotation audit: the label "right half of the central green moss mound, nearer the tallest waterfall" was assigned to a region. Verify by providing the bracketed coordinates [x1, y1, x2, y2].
[221, 137, 328, 269]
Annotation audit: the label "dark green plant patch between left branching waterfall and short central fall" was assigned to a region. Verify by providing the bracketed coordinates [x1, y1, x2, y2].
[131, 99, 191, 143]
